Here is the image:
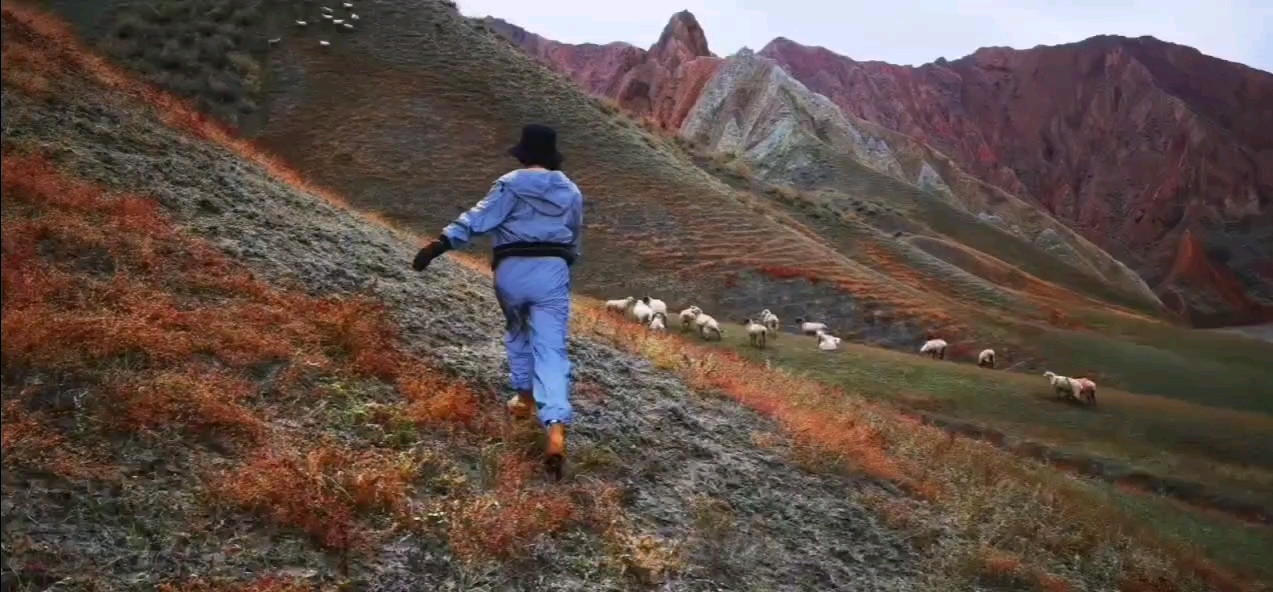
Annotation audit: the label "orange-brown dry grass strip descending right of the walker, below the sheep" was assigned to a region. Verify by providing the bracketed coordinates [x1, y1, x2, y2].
[575, 295, 1260, 591]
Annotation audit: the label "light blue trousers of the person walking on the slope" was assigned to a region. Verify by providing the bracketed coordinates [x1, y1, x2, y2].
[495, 257, 574, 425]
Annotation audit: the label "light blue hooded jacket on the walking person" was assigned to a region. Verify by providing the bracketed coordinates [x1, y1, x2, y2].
[442, 169, 583, 257]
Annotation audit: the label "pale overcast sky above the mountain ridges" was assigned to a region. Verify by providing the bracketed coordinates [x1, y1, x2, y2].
[458, 0, 1273, 71]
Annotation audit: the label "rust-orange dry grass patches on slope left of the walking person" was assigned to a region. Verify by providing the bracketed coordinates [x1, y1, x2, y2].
[3, 145, 626, 577]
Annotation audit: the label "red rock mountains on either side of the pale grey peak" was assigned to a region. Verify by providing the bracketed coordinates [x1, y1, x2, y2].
[488, 11, 1273, 325]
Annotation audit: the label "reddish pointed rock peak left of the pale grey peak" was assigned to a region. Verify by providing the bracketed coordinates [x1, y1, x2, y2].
[484, 11, 721, 129]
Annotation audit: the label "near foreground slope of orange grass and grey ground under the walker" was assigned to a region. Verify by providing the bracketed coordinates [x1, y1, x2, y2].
[0, 3, 1270, 591]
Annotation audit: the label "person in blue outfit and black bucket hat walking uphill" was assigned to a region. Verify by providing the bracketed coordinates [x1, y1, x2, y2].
[411, 123, 583, 479]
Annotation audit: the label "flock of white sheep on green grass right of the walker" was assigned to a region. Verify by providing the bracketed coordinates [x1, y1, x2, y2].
[606, 295, 1096, 405]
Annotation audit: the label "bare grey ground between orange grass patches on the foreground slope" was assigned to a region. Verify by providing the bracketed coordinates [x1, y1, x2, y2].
[3, 82, 922, 591]
